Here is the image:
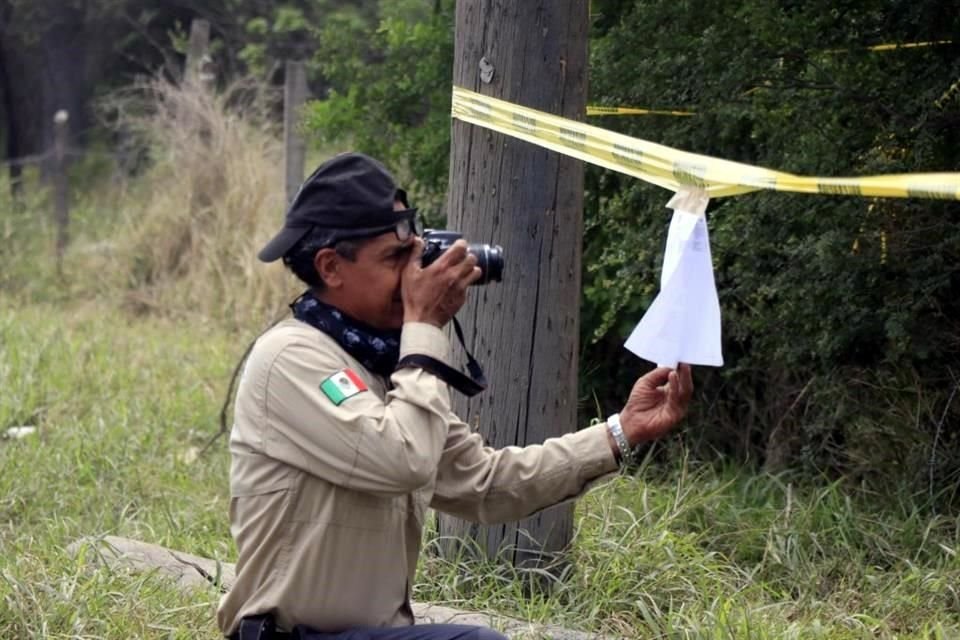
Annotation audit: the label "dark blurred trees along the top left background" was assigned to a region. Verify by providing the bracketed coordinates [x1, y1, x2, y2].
[0, 0, 375, 192]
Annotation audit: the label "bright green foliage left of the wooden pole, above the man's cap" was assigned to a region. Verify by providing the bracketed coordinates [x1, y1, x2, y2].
[307, 0, 454, 218]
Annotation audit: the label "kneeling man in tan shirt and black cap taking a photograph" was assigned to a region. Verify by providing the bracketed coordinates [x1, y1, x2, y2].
[218, 154, 692, 640]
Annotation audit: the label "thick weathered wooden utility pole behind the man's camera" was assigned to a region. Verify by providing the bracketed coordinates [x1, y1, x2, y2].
[440, 0, 589, 566]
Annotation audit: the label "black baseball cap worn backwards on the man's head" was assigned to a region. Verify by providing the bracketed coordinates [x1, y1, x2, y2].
[257, 153, 416, 262]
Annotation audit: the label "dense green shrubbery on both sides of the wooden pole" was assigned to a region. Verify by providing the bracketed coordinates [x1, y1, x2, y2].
[310, 0, 960, 500]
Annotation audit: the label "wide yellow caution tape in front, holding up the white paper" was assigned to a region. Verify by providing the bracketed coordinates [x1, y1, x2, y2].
[452, 87, 960, 200]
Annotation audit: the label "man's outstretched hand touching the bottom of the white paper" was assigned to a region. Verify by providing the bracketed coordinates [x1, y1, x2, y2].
[620, 364, 693, 447]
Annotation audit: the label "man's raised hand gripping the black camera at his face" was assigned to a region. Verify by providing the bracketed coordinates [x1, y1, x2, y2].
[400, 238, 483, 327]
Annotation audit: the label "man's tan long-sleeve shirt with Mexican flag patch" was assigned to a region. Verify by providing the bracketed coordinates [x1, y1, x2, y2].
[217, 320, 616, 635]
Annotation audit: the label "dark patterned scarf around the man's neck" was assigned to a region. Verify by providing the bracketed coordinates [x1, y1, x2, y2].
[290, 291, 400, 378]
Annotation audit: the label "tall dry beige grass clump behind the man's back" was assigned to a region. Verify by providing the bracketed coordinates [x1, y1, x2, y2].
[99, 81, 300, 328]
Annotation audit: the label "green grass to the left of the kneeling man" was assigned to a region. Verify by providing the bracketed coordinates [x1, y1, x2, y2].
[0, 306, 235, 638]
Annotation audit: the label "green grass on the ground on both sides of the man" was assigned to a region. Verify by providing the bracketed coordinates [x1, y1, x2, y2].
[0, 301, 960, 639]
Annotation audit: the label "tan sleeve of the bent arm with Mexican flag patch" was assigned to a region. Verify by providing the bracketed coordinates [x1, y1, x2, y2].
[263, 323, 450, 495]
